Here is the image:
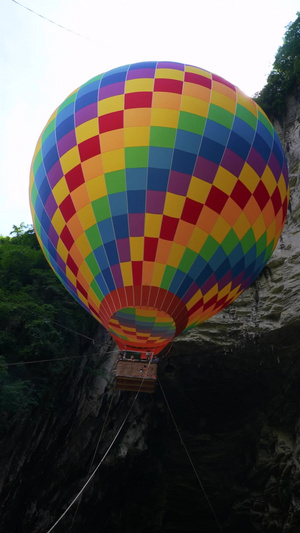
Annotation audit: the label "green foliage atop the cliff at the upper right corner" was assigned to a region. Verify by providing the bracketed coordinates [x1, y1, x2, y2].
[254, 12, 300, 118]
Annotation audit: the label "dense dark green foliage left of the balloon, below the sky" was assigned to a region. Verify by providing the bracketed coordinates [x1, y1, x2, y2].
[0, 225, 97, 431]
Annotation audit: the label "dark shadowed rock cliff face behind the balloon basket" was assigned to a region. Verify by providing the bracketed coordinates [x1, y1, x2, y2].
[0, 94, 300, 533]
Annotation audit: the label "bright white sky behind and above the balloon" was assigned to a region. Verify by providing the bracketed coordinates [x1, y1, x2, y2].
[0, 0, 300, 235]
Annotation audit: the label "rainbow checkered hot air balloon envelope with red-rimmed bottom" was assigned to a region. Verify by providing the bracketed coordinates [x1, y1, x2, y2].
[30, 62, 289, 353]
